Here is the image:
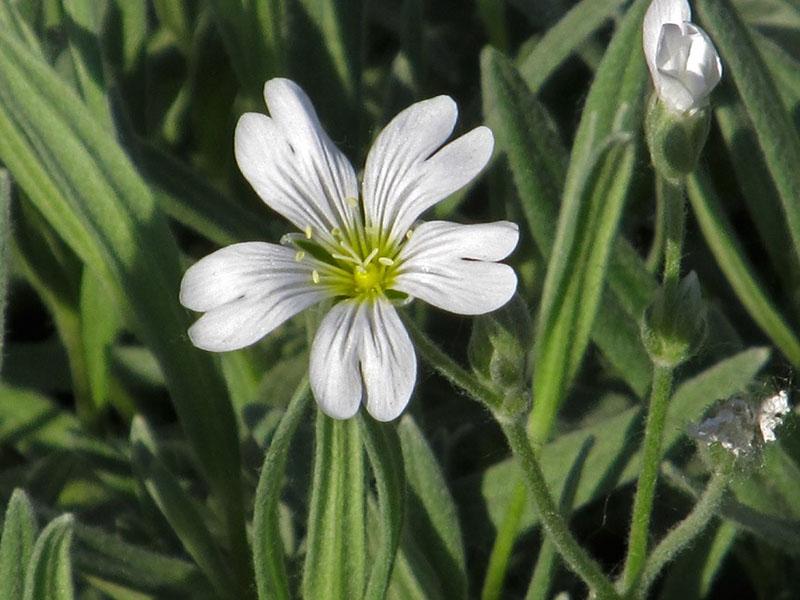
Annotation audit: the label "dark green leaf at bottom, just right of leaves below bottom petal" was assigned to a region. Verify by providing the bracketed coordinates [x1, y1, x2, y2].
[398, 415, 468, 600]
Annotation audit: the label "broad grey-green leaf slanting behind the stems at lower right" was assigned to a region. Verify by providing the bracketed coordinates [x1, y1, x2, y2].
[481, 348, 770, 529]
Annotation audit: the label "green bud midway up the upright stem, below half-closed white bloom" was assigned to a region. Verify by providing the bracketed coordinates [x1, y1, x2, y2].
[641, 271, 706, 367]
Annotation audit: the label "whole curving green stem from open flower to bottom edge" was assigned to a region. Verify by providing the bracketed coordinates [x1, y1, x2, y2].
[404, 319, 619, 600]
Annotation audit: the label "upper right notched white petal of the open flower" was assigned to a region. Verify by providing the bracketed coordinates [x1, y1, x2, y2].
[363, 96, 494, 246]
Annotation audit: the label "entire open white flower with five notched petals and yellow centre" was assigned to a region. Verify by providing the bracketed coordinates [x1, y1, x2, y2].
[180, 79, 519, 421]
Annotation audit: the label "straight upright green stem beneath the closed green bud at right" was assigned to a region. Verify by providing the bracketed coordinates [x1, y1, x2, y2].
[622, 365, 672, 590]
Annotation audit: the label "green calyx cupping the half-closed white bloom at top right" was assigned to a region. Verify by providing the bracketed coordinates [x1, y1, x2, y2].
[645, 95, 711, 182]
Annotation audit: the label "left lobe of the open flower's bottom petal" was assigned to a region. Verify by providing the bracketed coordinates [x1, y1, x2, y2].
[309, 301, 367, 419]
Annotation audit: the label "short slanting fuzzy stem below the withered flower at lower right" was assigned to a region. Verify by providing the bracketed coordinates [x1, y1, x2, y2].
[636, 463, 732, 598]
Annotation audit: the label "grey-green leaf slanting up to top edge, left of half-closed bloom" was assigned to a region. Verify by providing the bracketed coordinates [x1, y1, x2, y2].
[519, 0, 625, 92]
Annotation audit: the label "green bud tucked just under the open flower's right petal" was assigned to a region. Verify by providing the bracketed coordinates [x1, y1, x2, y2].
[467, 294, 533, 394]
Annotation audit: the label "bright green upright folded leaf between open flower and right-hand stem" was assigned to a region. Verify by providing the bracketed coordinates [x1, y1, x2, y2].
[529, 138, 634, 441]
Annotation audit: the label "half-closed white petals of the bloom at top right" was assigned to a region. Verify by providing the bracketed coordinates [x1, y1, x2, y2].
[642, 0, 722, 113]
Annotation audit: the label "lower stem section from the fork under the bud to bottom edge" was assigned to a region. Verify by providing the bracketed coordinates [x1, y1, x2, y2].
[500, 420, 619, 600]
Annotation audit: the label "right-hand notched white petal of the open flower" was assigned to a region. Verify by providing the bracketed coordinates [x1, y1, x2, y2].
[393, 221, 519, 315]
